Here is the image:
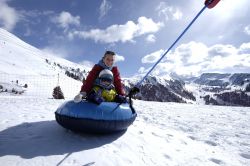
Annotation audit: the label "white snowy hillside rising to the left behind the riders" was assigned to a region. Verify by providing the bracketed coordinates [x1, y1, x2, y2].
[0, 28, 89, 98]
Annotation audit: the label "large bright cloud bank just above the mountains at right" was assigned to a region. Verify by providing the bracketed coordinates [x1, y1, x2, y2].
[140, 42, 250, 76]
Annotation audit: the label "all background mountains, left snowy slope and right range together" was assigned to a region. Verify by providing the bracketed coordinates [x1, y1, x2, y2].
[0, 28, 250, 106]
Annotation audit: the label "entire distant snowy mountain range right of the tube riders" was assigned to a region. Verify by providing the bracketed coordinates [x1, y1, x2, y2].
[125, 73, 250, 106]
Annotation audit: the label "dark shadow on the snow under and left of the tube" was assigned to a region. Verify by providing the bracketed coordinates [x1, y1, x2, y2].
[0, 121, 126, 159]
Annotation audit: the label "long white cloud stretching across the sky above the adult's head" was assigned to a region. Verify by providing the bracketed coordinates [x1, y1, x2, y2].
[68, 17, 164, 43]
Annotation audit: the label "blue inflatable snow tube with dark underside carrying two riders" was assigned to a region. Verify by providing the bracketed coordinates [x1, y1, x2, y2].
[55, 100, 137, 133]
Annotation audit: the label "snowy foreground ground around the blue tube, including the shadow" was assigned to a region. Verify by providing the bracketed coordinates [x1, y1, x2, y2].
[0, 96, 250, 166]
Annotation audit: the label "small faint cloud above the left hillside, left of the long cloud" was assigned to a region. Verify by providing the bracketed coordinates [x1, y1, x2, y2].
[52, 11, 80, 29]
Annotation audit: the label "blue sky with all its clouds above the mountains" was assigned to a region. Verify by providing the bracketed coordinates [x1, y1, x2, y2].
[0, 0, 250, 77]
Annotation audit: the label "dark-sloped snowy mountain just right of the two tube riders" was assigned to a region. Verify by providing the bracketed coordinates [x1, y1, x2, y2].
[124, 76, 196, 103]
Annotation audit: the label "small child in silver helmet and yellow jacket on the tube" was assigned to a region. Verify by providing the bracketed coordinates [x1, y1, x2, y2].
[87, 69, 127, 104]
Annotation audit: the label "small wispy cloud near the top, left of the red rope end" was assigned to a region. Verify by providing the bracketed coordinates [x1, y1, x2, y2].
[156, 2, 182, 21]
